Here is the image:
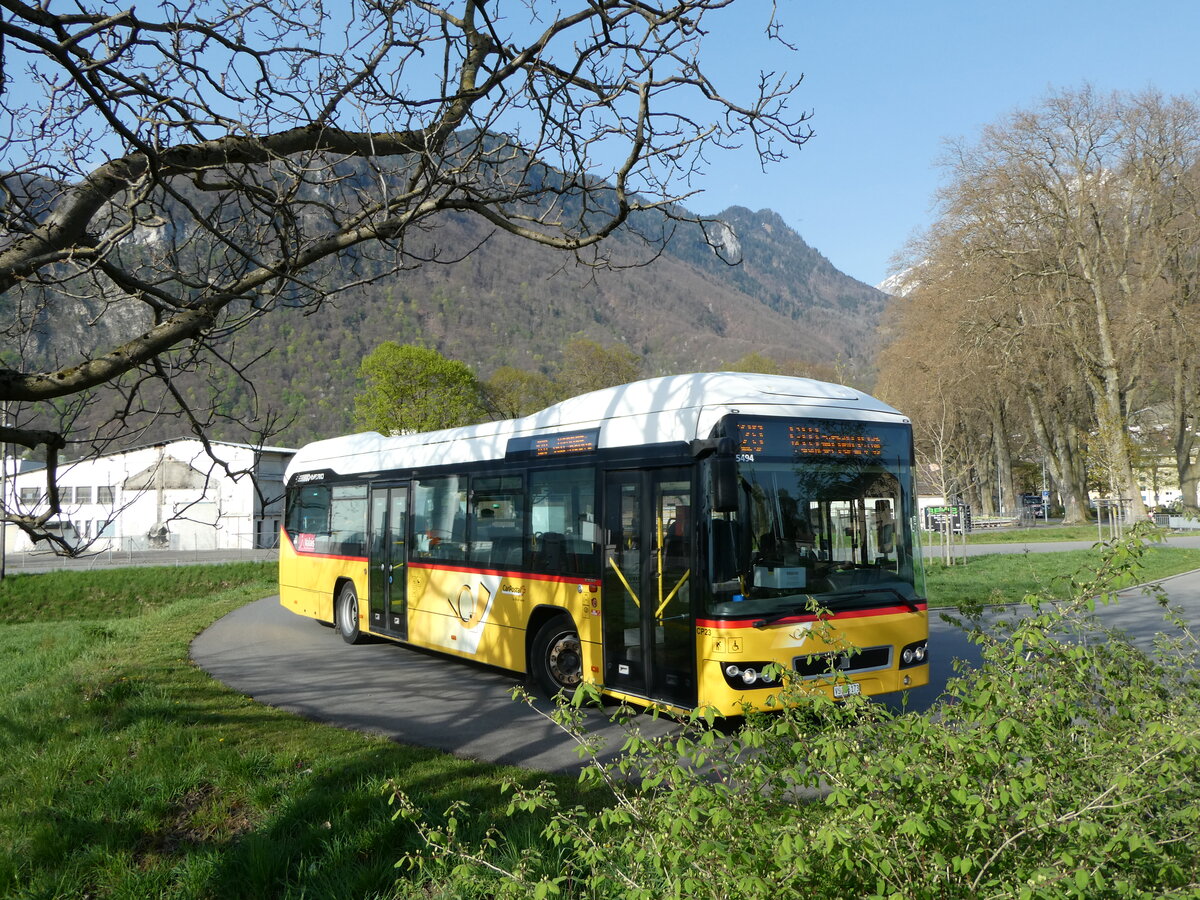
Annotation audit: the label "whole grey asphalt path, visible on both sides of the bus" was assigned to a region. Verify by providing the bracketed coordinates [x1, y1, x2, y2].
[192, 538, 1200, 773]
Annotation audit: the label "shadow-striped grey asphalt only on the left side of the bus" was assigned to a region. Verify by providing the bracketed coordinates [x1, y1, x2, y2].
[184, 596, 668, 772]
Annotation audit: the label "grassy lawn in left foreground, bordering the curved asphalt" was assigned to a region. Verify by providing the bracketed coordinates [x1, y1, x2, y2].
[0, 563, 575, 900]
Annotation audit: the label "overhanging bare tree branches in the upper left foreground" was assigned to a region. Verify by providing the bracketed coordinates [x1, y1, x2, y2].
[0, 0, 809, 549]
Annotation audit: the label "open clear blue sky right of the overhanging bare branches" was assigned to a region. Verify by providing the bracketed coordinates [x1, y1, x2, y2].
[688, 0, 1200, 284]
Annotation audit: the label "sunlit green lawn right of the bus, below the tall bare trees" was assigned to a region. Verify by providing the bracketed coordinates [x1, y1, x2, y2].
[925, 546, 1200, 606]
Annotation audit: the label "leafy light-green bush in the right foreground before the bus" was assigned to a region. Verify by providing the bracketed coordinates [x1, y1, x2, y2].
[395, 525, 1200, 900]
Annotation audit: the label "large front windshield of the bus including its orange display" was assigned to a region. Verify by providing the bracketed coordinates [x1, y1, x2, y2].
[708, 419, 924, 620]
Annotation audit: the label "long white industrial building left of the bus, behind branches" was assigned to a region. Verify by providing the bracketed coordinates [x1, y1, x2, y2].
[4, 438, 295, 553]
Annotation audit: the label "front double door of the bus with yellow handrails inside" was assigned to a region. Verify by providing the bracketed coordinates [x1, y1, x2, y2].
[602, 468, 696, 706]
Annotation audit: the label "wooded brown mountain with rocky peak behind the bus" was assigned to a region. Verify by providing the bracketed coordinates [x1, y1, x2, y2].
[0, 178, 886, 445]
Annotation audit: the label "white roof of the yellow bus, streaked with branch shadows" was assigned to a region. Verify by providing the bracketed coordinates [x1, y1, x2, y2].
[286, 372, 908, 480]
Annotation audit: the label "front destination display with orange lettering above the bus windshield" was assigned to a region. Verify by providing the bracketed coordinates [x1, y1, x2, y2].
[736, 419, 907, 460]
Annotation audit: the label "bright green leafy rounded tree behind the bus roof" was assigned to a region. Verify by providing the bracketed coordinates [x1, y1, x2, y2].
[354, 341, 487, 434]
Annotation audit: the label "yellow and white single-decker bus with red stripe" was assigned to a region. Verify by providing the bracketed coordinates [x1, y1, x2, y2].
[280, 372, 929, 714]
